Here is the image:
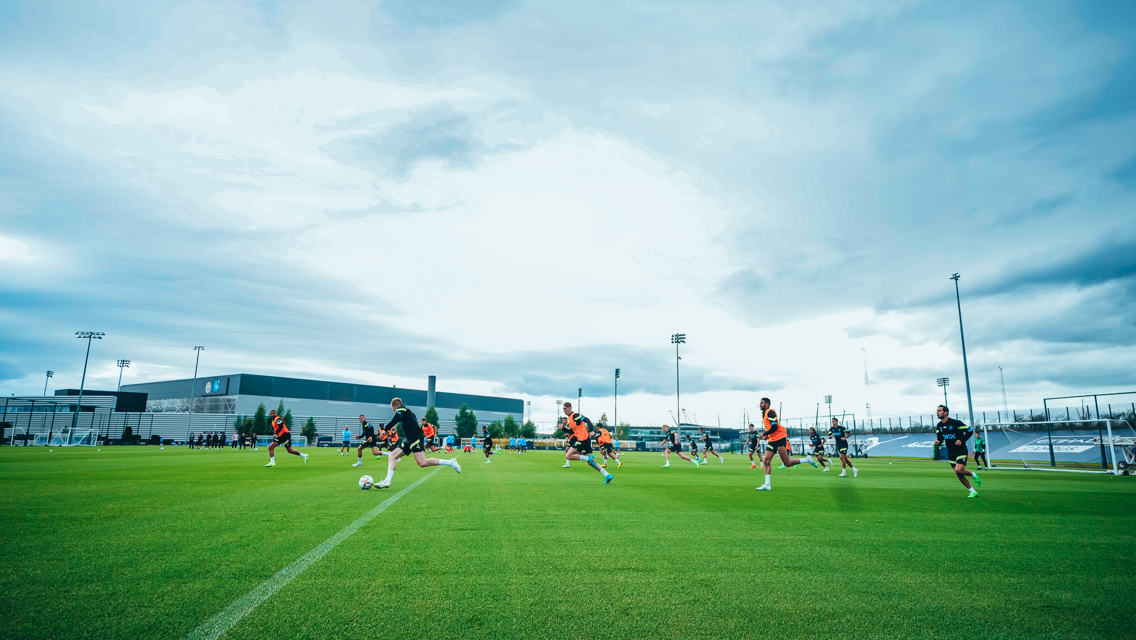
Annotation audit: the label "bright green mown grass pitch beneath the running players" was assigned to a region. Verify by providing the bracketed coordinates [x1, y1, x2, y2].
[0, 447, 1136, 640]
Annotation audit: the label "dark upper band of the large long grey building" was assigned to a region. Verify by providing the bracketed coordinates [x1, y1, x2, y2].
[123, 373, 525, 416]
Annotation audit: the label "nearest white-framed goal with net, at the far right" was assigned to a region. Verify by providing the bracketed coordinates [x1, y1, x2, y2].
[968, 419, 1136, 474]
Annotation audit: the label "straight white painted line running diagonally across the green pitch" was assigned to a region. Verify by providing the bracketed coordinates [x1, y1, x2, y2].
[185, 466, 442, 640]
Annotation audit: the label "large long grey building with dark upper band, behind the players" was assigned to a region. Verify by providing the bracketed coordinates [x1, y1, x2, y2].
[123, 373, 525, 432]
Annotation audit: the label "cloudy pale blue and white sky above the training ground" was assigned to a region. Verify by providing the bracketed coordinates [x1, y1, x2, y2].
[0, 0, 1136, 426]
